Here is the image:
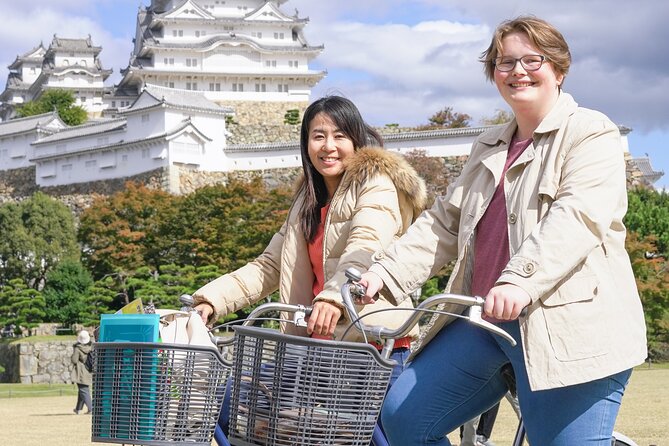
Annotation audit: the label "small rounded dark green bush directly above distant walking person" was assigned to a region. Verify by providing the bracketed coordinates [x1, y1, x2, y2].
[42, 260, 93, 326]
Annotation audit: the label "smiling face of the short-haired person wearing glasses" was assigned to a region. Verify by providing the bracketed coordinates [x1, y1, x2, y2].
[494, 32, 564, 118]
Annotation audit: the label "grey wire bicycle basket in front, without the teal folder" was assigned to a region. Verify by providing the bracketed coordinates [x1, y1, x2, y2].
[229, 327, 394, 446]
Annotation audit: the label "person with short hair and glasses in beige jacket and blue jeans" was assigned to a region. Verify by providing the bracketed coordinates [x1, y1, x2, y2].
[362, 17, 647, 446]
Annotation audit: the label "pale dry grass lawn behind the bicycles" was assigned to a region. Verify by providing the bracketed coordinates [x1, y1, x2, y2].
[0, 364, 669, 446]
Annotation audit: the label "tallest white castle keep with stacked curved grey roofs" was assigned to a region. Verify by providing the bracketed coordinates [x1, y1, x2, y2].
[109, 0, 325, 123]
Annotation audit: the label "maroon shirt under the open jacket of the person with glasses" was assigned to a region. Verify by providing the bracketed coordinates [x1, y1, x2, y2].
[471, 137, 532, 297]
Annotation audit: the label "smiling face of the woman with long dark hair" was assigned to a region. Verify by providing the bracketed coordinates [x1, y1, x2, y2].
[308, 112, 355, 198]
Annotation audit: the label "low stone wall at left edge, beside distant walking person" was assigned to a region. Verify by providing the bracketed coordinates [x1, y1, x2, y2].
[0, 341, 74, 384]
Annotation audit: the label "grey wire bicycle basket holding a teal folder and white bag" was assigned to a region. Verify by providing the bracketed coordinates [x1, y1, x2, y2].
[91, 342, 230, 446]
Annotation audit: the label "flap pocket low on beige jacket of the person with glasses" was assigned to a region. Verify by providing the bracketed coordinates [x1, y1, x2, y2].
[542, 274, 607, 361]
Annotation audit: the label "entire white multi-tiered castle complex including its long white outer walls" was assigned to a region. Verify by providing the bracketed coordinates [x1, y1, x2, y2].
[0, 0, 660, 193]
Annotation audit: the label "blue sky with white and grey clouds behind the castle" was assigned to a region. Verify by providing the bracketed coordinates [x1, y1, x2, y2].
[0, 0, 669, 188]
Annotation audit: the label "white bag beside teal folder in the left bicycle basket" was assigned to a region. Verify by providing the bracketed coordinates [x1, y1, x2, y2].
[156, 309, 216, 349]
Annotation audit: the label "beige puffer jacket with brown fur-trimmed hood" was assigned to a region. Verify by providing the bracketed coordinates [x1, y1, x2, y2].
[193, 148, 426, 340]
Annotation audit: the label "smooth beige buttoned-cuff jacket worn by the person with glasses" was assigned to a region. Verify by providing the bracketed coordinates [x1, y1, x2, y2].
[371, 93, 647, 390]
